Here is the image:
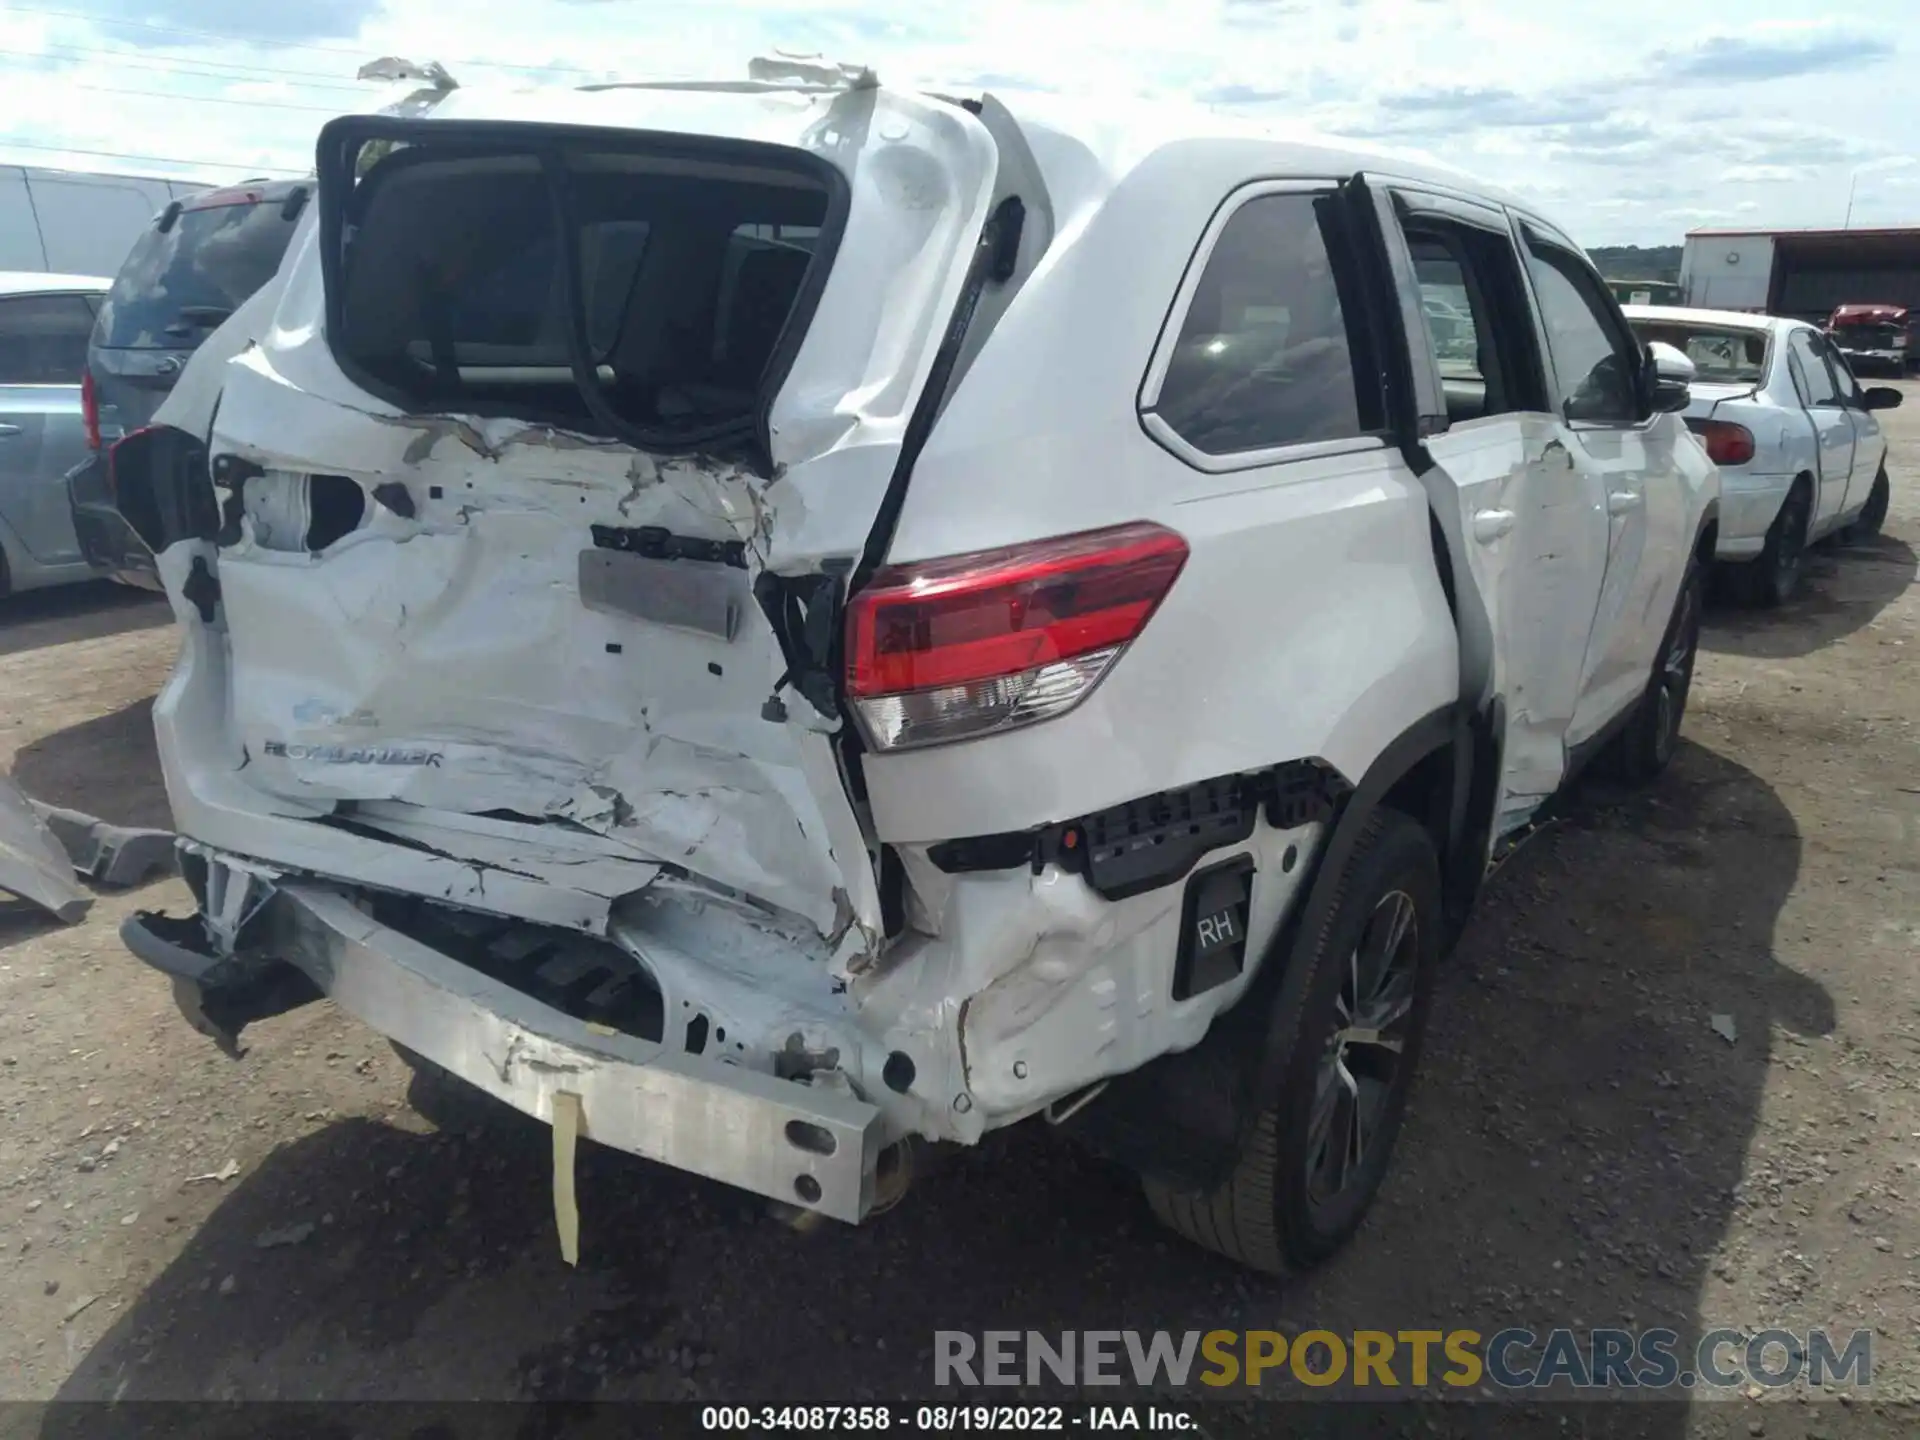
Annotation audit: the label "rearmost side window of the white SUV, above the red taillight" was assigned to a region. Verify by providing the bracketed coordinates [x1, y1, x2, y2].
[1152, 194, 1380, 455]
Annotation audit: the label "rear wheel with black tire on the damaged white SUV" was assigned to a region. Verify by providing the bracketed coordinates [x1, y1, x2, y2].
[1142, 810, 1444, 1275]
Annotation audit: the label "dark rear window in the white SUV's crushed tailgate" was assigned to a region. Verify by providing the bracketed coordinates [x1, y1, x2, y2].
[323, 123, 835, 444]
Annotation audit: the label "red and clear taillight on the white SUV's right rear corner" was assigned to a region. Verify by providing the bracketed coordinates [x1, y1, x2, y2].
[847, 522, 1187, 751]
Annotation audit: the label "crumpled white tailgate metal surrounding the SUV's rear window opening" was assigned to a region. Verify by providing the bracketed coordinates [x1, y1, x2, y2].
[156, 76, 996, 948]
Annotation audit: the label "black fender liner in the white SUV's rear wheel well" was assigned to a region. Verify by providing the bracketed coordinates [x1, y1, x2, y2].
[1060, 705, 1459, 1190]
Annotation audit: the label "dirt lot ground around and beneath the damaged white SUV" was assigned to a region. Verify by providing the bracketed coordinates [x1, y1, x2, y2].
[0, 386, 1920, 1436]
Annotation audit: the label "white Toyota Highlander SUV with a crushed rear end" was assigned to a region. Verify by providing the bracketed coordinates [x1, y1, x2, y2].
[115, 73, 1716, 1269]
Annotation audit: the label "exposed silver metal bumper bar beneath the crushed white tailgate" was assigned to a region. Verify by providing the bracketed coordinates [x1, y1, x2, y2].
[134, 883, 881, 1223]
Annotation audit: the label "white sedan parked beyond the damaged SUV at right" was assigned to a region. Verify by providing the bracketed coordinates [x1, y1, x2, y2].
[1622, 305, 1901, 605]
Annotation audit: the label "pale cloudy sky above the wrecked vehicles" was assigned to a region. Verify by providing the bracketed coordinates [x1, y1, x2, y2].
[0, 0, 1920, 246]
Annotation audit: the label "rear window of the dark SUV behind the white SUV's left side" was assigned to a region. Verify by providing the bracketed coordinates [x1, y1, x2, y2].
[94, 190, 300, 349]
